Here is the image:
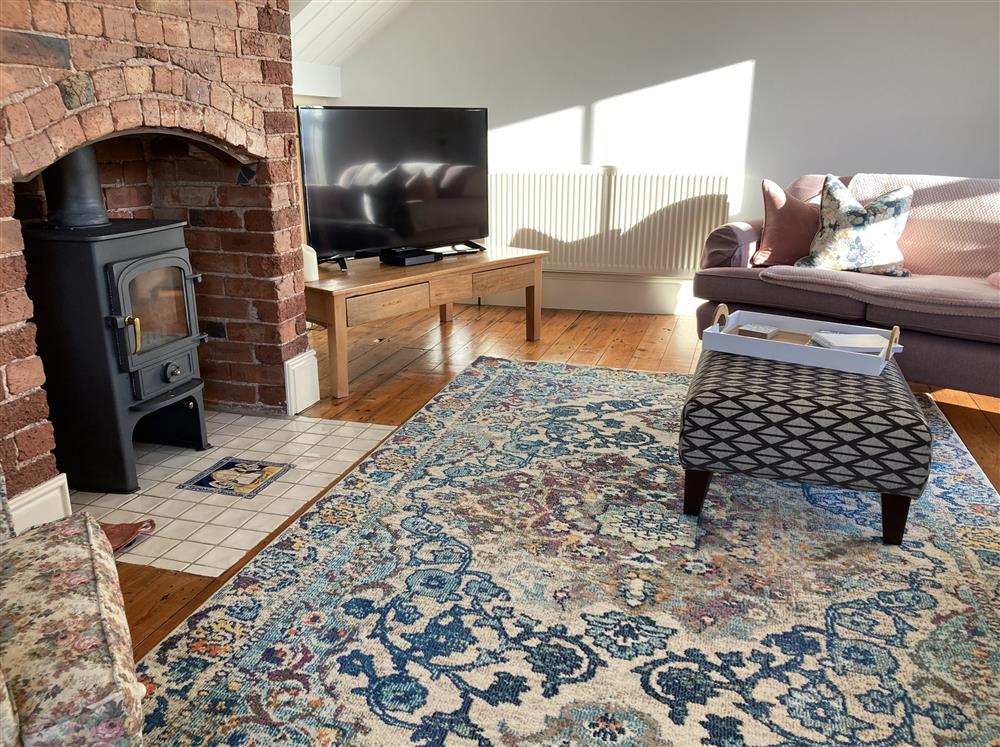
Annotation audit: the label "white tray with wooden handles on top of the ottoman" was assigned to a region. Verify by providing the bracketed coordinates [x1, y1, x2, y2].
[702, 304, 903, 376]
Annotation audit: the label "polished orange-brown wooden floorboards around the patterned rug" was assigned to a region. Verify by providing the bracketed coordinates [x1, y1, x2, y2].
[118, 306, 1000, 659]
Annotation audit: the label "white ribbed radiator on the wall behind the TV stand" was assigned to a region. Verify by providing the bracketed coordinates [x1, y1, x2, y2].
[490, 167, 729, 276]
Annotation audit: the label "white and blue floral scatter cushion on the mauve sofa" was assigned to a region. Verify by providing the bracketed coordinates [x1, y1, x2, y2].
[795, 174, 913, 275]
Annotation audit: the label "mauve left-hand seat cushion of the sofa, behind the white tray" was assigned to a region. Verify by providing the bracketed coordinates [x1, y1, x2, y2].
[694, 267, 865, 320]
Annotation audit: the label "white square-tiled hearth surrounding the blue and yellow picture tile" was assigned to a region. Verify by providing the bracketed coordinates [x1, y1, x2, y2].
[70, 411, 393, 576]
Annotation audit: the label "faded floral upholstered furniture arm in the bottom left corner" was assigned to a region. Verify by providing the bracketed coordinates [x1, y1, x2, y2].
[0, 513, 145, 747]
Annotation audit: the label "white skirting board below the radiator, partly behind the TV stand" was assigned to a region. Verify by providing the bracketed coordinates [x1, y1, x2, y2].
[483, 270, 701, 316]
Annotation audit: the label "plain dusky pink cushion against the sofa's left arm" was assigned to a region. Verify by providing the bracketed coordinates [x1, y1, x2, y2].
[750, 179, 819, 267]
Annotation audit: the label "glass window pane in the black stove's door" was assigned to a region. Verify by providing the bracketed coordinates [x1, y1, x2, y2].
[128, 266, 190, 353]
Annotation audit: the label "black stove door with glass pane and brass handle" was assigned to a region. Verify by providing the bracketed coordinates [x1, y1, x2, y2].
[110, 249, 200, 376]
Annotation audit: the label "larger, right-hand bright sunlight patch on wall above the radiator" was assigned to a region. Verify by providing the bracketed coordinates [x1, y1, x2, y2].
[590, 60, 754, 214]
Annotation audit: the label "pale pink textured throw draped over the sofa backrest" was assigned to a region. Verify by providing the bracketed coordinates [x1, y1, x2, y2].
[851, 174, 1000, 278]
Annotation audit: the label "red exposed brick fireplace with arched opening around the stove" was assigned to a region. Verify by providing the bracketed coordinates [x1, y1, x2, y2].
[0, 0, 307, 502]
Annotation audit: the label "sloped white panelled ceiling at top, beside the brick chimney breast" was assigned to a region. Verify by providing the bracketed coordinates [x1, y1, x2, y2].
[290, 0, 411, 66]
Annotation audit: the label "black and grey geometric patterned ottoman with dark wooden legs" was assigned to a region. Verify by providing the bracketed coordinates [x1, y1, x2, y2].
[680, 350, 931, 545]
